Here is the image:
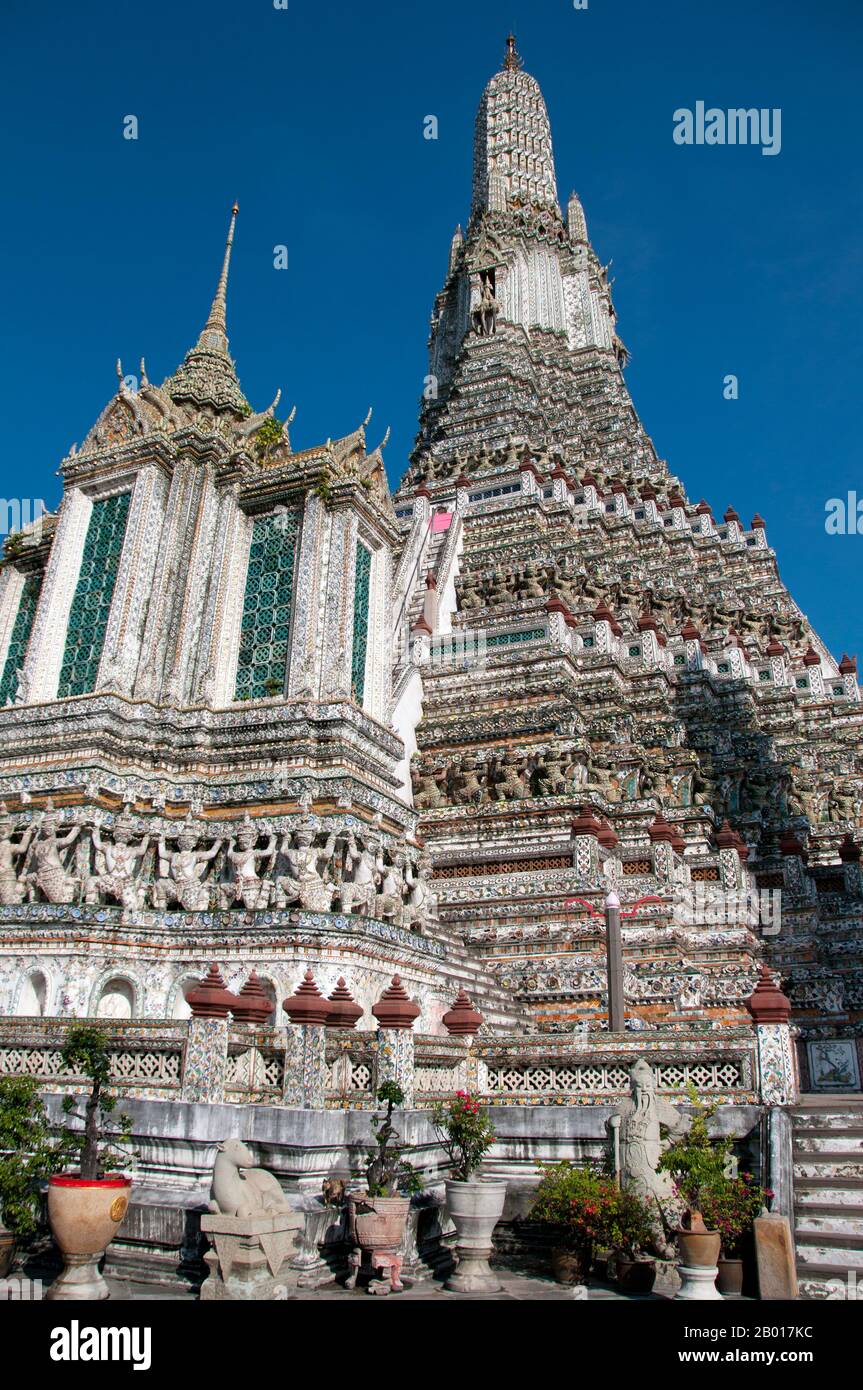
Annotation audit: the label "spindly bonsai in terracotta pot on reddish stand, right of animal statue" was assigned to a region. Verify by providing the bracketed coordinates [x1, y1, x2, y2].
[346, 1081, 421, 1290]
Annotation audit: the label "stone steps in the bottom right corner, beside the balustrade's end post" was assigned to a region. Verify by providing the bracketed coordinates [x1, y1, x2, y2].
[791, 1095, 863, 1300]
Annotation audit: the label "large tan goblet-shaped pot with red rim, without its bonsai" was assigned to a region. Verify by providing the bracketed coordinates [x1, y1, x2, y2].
[46, 1173, 132, 1300]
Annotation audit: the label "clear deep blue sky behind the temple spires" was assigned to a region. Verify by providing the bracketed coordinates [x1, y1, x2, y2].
[0, 0, 863, 667]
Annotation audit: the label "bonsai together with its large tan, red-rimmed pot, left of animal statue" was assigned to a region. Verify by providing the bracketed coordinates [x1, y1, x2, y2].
[46, 1024, 132, 1300]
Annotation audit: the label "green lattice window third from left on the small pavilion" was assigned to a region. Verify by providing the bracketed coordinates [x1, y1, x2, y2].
[233, 512, 300, 699]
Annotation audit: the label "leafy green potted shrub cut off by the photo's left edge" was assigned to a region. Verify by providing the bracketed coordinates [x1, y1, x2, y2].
[0, 1076, 71, 1279]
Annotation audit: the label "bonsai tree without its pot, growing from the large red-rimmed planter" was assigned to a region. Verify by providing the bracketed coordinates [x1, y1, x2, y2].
[61, 1023, 132, 1182]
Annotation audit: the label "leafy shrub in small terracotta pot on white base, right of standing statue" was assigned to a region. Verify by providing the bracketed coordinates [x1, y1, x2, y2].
[656, 1084, 731, 1298]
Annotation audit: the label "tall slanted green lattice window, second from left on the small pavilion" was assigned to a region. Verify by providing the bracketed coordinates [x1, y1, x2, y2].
[57, 492, 131, 699]
